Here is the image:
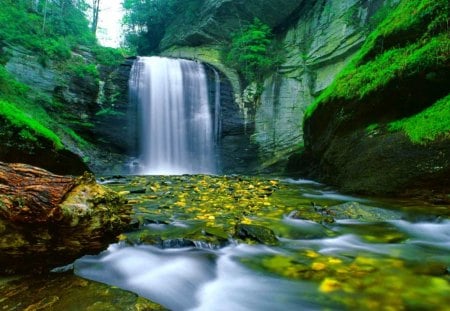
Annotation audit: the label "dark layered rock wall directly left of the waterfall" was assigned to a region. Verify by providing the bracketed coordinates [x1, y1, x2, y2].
[0, 46, 131, 174]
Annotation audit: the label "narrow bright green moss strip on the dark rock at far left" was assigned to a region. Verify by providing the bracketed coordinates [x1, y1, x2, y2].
[0, 100, 64, 149]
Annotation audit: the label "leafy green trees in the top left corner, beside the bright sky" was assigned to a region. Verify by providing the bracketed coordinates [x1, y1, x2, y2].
[0, 0, 95, 59]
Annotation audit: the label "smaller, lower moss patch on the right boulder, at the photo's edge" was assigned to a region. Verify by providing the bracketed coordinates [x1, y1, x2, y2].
[388, 94, 450, 144]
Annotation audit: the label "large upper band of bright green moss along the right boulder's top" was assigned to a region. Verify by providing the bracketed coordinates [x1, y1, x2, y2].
[305, 0, 450, 118]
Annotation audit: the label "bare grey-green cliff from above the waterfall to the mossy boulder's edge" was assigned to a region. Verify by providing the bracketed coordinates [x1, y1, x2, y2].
[162, 0, 395, 171]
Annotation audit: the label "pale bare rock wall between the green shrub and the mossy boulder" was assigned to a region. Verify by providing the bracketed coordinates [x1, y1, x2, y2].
[253, 0, 383, 165]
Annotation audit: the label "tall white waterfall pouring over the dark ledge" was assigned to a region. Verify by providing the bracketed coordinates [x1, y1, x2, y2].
[130, 57, 220, 175]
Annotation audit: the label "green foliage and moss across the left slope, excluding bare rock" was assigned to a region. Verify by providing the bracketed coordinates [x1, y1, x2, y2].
[0, 0, 124, 156]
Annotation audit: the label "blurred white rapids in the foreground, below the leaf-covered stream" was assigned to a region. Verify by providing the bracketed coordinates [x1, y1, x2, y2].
[75, 244, 319, 311]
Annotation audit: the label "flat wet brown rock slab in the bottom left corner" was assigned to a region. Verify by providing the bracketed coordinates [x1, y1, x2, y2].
[0, 274, 166, 311]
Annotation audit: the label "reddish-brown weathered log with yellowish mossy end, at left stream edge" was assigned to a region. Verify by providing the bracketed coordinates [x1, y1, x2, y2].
[0, 162, 131, 274]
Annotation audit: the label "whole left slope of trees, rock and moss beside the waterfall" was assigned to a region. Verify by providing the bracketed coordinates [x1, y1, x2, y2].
[0, 0, 123, 174]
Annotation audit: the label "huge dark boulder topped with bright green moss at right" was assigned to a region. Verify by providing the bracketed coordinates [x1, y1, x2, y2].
[300, 0, 450, 195]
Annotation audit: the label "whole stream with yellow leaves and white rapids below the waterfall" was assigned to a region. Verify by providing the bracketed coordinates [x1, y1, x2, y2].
[75, 176, 450, 310]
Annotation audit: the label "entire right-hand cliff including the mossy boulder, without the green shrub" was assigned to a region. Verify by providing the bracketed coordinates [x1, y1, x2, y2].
[163, 0, 450, 194]
